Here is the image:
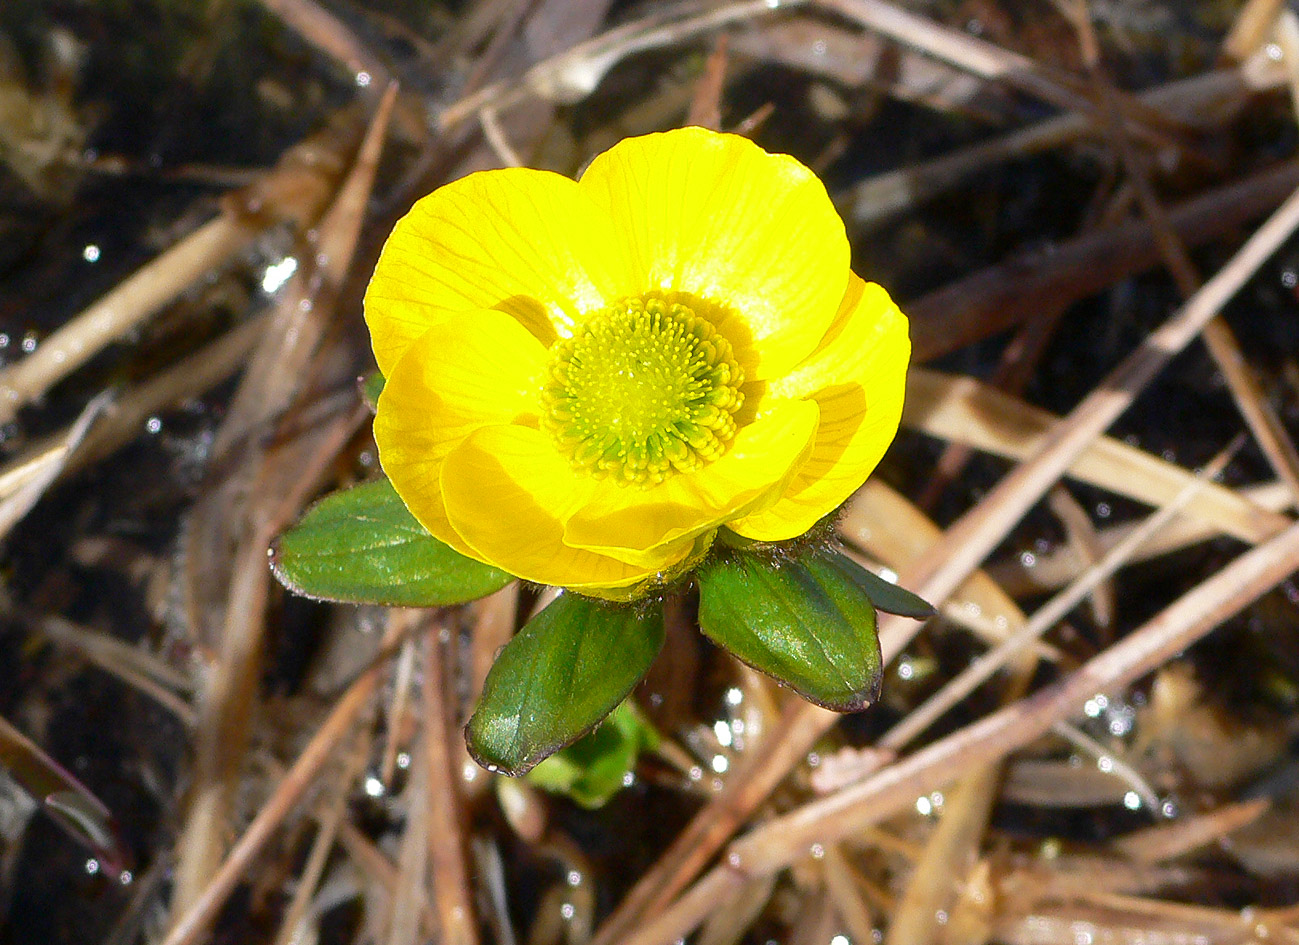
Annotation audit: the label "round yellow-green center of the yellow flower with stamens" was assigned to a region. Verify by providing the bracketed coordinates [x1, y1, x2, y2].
[542, 298, 744, 485]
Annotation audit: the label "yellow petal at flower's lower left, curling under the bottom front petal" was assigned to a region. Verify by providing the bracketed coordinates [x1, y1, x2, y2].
[442, 426, 670, 590]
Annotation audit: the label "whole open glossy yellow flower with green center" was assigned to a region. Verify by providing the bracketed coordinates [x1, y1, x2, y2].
[365, 127, 911, 599]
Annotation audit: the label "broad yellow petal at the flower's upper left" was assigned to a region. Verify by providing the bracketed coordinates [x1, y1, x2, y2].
[365, 168, 624, 374]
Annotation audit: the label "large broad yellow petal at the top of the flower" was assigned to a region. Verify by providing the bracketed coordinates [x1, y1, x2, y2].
[581, 127, 848, 378]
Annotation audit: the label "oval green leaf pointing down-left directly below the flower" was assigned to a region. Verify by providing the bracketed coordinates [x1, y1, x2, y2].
[465, 593, 664, 775]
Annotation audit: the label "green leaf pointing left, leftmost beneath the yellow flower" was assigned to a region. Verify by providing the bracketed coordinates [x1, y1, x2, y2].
[270, 480, 513, 607]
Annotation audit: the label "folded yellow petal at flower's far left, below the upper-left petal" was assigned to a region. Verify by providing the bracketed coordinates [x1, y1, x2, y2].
[374, 309, 546, 554]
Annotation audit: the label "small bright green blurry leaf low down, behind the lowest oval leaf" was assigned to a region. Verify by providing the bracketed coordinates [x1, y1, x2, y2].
[527, 699, 660, 810]
